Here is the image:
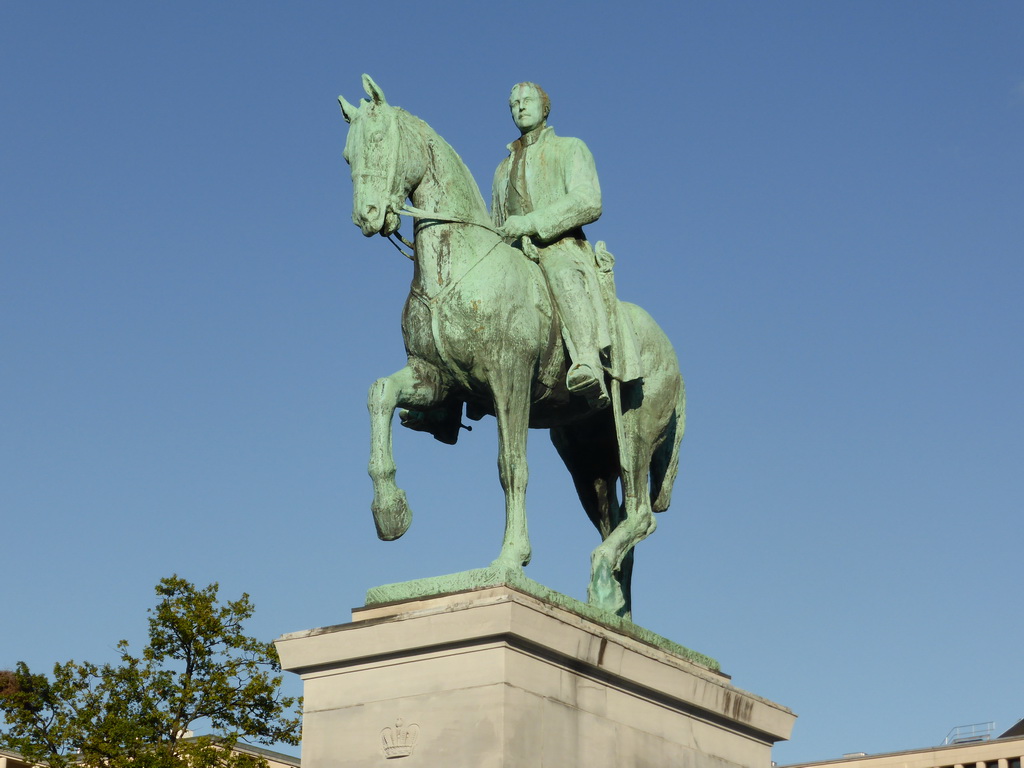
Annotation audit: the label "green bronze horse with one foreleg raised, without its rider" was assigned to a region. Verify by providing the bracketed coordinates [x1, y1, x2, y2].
[338, 75, 685, 617]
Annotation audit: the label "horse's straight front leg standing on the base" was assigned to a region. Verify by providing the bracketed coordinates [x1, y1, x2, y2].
[492, 371, 530, 568]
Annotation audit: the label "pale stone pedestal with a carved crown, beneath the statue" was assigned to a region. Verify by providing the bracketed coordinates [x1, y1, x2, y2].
[278, 586, 795, 768]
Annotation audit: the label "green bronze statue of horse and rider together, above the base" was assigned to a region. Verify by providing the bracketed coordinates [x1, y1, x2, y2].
[338, 75, 686, 617]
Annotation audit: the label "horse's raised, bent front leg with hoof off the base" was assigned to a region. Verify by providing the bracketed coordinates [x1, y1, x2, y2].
[367, 366, 440, 542]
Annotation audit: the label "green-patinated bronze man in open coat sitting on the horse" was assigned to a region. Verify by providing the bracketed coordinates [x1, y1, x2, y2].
[490, 83, 610, 409]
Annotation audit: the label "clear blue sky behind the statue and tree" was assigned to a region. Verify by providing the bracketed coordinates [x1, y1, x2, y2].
[0, 0, 1024, 763]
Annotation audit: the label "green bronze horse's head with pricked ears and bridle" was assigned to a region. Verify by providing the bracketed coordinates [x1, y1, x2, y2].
[338, 75, 426, 238]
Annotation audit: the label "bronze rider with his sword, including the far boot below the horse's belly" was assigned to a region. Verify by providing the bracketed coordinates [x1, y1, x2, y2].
[399, 78, 630, 443]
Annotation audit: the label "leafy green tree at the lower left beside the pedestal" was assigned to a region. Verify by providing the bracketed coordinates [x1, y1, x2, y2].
[0, 575, 301, 768]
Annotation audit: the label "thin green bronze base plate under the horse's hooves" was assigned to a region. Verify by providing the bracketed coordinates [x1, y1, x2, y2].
[367, 565, 722, 672]
